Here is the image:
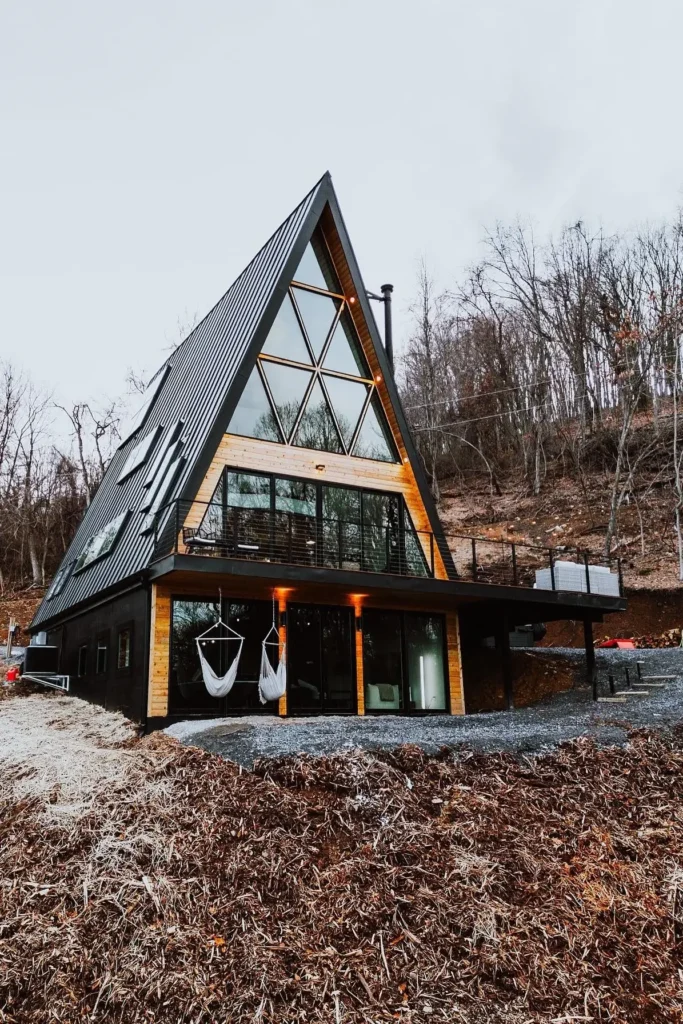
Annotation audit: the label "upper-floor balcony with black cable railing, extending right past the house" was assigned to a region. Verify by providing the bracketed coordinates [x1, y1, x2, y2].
[158, 501, 624, 596]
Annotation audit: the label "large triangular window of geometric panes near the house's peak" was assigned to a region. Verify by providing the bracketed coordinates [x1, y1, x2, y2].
[227, 232, 398, 462]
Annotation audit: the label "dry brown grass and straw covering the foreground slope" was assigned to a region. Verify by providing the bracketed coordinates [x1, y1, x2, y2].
[0, 696, 683, 1024]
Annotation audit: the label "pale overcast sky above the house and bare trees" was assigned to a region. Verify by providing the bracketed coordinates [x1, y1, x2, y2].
[0, 0, 683, 411]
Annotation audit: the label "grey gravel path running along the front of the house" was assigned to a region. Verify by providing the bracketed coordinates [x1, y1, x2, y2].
[166, 648, 683, 767]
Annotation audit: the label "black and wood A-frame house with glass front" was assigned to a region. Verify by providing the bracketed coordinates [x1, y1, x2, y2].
[32, 174, 623, 728]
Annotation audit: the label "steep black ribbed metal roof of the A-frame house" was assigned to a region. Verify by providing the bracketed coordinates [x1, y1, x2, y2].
[32, 173, 450, 632]
